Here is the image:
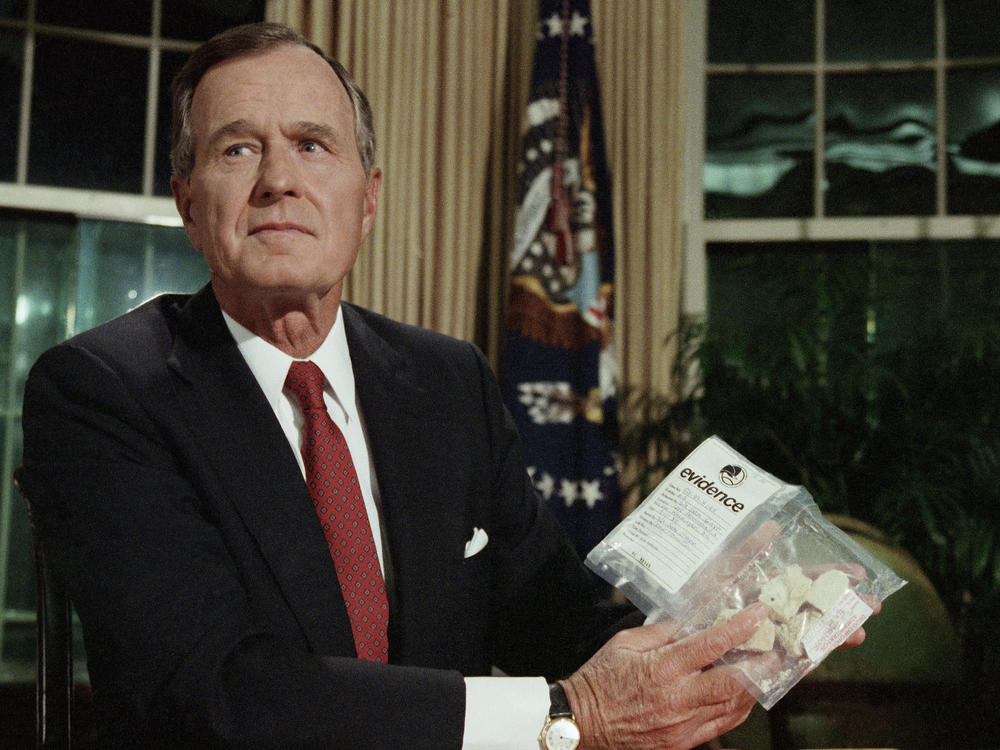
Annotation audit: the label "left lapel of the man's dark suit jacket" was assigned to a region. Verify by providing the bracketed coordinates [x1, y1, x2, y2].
[168, 287, 354, 653]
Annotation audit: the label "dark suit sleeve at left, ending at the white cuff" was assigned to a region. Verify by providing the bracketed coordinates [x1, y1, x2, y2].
[23, 344, 465, 748]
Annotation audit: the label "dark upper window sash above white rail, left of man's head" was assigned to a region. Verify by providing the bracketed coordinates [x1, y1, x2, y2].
[0, 0, 264, 196]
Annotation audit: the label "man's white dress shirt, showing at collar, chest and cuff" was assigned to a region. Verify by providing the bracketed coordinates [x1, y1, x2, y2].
[222, 312, 549, 750]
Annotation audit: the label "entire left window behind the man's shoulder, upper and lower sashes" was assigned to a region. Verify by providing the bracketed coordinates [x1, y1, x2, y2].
[0, 0, 265, 681]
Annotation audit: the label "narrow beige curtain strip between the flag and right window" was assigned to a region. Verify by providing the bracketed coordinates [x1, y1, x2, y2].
[592, 0, 684, 400]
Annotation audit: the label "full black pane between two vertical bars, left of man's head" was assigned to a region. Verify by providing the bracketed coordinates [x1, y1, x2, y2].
[28, 37, 149, 193]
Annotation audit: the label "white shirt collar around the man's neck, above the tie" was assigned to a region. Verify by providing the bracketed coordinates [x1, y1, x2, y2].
[222, 309, 357, 418]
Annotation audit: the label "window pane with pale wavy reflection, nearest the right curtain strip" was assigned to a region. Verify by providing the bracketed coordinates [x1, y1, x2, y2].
[704, 75, 815, 218]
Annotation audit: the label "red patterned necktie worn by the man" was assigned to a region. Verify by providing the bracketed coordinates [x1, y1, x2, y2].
[285, 362, 389, 662]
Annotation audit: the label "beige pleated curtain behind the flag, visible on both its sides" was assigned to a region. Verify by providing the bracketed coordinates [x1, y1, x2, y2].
[269, 0, 684, 400]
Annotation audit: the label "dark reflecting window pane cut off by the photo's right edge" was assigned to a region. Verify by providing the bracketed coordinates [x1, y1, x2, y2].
[947, 68, 1000, 214]
